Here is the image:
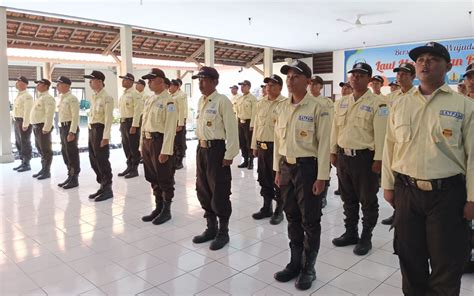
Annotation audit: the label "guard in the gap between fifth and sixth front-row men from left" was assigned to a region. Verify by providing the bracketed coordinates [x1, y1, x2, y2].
[170, 78, 188, 170]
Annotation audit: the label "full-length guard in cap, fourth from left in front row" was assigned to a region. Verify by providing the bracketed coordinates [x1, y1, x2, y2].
[84, 70, 114, 202]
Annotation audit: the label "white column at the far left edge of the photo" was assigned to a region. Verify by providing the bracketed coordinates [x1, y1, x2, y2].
[0, 7, 14, 163]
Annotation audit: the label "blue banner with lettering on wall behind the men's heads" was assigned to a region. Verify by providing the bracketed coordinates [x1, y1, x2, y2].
[344, 39, 474, 85]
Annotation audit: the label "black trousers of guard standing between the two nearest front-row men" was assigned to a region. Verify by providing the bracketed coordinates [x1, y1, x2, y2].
[337, 149, 379, 230]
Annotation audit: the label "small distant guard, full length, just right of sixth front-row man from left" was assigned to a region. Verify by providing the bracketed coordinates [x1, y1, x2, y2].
[235, 80, 257, 170]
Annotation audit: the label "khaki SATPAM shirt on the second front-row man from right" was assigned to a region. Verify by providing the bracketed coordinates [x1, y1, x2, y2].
[273, 93, 331, 180]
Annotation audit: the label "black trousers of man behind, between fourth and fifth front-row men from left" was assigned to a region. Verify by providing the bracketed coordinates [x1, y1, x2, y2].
[120, 118, 141, 167]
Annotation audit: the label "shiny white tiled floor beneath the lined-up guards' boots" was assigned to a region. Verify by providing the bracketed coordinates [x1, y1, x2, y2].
[0, 141, 474, 296]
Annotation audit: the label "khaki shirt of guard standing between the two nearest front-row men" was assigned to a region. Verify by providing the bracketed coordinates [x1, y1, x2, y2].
[331, 90, 389, 160]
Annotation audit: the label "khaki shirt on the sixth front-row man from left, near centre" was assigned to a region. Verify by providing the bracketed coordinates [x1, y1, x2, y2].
[196, 91, 239, 160]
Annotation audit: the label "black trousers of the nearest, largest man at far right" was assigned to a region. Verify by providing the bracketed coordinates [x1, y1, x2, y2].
[394, 175, 470, 296]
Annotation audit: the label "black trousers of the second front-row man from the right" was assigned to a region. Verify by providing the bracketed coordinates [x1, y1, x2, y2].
[280, 157, 322, 252]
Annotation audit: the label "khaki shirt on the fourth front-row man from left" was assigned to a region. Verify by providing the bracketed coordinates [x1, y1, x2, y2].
[89, 89, 114, 139]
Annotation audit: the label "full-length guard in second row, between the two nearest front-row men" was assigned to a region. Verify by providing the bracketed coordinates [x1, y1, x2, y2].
[331, 63, 388, 256]
